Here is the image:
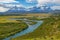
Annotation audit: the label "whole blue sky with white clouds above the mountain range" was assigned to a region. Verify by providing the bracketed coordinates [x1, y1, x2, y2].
[0, 0, 60, 12]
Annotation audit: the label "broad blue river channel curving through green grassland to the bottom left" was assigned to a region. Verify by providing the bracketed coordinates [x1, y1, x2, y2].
[3, 18, 43, 40]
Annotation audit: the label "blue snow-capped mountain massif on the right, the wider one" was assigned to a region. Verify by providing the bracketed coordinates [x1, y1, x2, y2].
[25, 6, 52, 12]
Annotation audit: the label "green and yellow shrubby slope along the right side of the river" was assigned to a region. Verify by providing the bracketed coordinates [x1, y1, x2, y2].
[12, 15, 60, 40]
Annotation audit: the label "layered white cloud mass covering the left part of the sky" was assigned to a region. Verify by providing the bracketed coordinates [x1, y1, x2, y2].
[0, 0, 22, 12]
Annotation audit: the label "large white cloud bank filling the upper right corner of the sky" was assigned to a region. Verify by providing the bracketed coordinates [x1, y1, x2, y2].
[36, 0, 60, 10]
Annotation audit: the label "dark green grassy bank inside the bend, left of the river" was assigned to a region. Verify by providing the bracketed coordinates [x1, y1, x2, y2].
[0, 21, 28, 40]
